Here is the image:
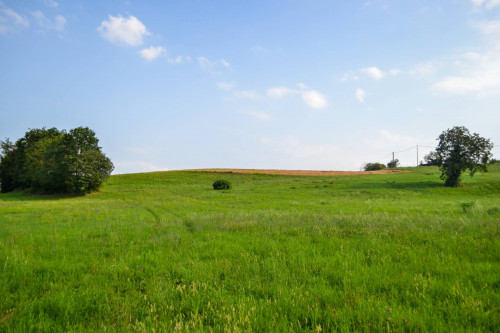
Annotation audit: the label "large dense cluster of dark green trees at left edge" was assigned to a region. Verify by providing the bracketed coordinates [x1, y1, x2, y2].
[0, 127, 114, 194]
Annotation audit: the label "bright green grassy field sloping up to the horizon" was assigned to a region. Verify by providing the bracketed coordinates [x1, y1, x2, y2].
[0, 164, 500, 332]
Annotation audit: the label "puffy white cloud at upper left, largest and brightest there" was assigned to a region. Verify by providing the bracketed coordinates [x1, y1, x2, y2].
[97, 15, 150, 46]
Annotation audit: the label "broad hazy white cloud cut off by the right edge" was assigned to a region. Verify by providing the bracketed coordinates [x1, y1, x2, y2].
[432, 21, 500, 97]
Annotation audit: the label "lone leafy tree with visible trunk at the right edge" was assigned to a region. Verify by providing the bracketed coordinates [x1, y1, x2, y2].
[436, 126, 493, 187]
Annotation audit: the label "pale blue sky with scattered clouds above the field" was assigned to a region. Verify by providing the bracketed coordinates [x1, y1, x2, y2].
[0, 0, 500, 173]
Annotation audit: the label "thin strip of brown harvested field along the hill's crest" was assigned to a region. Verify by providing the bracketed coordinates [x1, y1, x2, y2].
[185, 169, 408, 176]
